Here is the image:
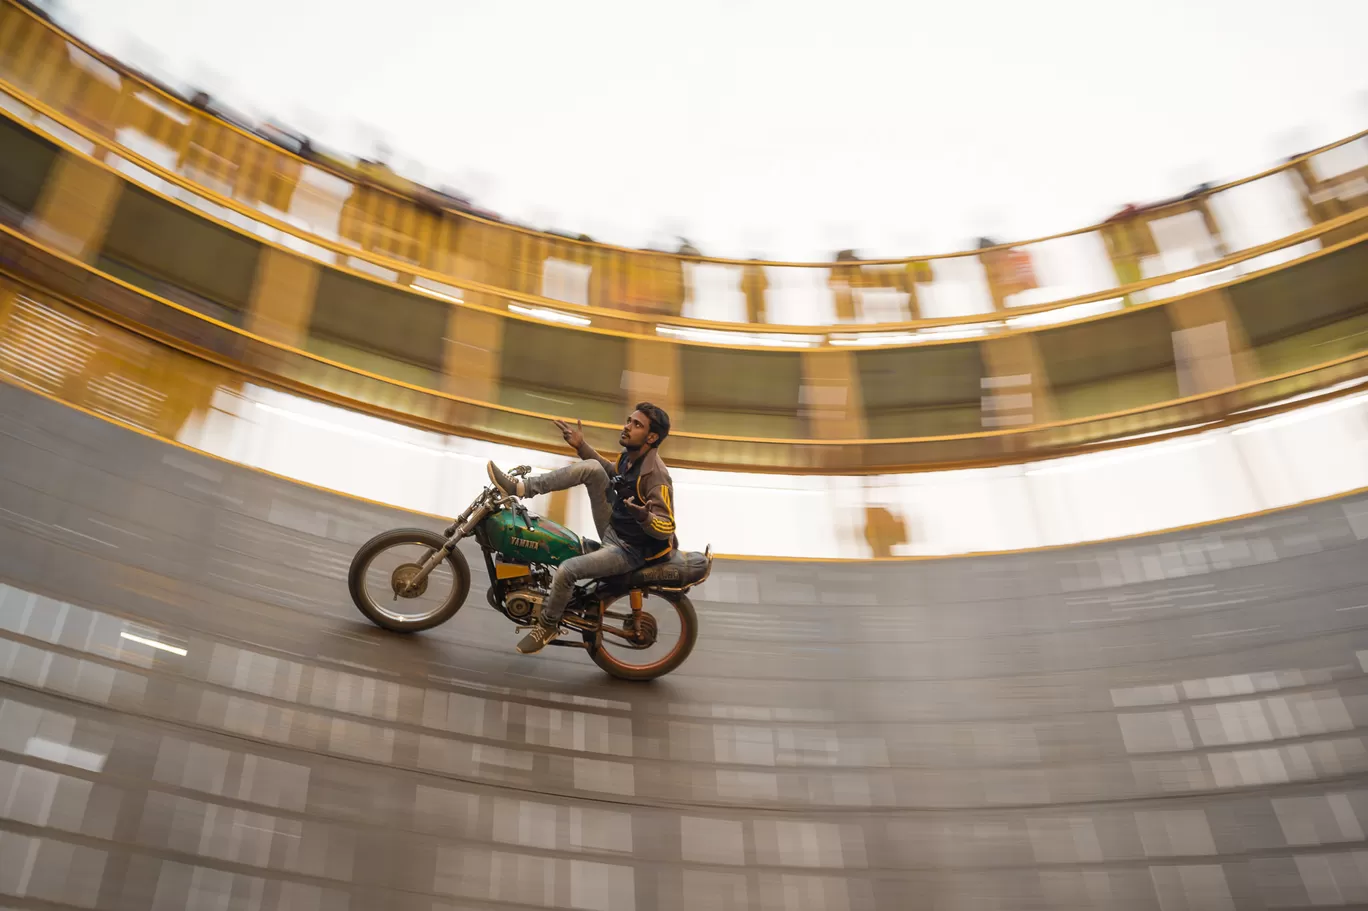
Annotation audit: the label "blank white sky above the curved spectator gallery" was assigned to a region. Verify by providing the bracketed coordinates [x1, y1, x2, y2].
[53, 0, 1368, 259]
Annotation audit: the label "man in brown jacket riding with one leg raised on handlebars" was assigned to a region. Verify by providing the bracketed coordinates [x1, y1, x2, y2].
[488, 402, 677, 655]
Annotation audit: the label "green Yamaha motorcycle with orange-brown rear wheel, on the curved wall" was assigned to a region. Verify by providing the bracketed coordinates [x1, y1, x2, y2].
[347, 465, 713, 680]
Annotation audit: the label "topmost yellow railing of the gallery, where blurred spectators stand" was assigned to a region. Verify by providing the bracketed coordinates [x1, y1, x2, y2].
[0, 0, 1368, 340]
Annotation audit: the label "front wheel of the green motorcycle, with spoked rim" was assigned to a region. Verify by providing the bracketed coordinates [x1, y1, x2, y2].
[347, 528, 471, 632]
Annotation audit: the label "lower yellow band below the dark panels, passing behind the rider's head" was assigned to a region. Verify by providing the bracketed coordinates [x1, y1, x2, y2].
[0, 221, 1368, 475]
